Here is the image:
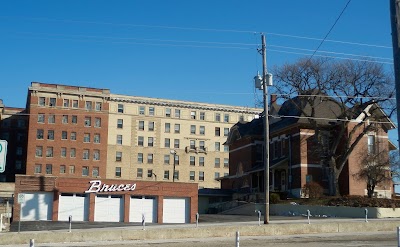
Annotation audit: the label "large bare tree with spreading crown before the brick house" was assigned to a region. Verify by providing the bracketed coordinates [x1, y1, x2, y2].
[271, 59, 395, 195]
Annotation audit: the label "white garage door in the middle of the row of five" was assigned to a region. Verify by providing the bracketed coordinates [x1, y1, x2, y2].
[94, 195, 124, 222]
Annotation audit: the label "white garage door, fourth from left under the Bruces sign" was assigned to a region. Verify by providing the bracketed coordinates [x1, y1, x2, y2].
[129, 196, 157, 223]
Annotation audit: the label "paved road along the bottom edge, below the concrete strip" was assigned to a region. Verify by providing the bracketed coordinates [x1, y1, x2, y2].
[3, 232, 398, 247]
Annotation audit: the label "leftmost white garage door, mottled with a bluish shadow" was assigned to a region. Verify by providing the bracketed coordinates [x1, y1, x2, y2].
[21, 192, 53, 221]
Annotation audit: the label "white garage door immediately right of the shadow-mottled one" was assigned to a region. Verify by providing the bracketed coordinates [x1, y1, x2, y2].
[58, 193, 89, 221]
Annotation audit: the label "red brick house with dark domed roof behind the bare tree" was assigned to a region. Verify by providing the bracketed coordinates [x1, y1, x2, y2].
[221, 95, 396, 199]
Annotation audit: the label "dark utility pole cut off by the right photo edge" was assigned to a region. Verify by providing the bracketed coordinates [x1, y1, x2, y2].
[390, 0, 400, 149]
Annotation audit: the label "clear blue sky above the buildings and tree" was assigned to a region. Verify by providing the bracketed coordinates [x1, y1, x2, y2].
[0, 0, 393, 107]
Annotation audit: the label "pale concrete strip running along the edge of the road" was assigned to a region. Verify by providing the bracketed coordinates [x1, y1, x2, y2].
[0, 218, 400, 245]
